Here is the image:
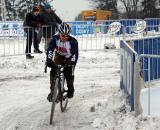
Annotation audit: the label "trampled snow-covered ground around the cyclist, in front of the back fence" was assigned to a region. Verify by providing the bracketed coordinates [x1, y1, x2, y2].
[0, 49, 160, 130]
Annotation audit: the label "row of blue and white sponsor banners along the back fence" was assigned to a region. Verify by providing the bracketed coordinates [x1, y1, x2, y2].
[0, 18, 160, 36]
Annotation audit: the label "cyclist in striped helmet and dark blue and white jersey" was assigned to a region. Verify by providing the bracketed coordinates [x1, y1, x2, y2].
[47, 23, 78, 102]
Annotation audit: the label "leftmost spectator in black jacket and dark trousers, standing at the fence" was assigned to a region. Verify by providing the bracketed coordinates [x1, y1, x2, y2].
[24, 6, 42, 59]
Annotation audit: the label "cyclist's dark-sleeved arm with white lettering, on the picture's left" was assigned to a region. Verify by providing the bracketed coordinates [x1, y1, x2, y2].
[47, 38, 56, 68]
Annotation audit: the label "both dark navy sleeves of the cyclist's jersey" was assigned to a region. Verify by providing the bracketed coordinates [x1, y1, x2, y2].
[47, 35, 78, 67]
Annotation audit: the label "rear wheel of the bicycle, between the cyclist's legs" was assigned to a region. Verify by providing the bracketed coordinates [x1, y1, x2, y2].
[59, 78, 68, 112]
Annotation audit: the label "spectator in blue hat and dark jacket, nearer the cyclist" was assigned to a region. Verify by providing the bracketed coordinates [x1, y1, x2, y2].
[41, 3, 62, 49]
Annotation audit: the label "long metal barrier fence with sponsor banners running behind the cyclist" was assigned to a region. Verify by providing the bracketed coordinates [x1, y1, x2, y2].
[0, 18, 160, 56]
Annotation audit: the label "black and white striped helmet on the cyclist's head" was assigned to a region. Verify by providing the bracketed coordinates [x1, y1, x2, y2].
[58, 23, 71, 35]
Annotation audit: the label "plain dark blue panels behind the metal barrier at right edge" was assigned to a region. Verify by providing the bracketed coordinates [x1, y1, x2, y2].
[133, 36, 160, 81]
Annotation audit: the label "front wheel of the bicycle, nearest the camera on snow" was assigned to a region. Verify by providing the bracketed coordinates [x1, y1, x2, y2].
[50, 79, 59, 124]
